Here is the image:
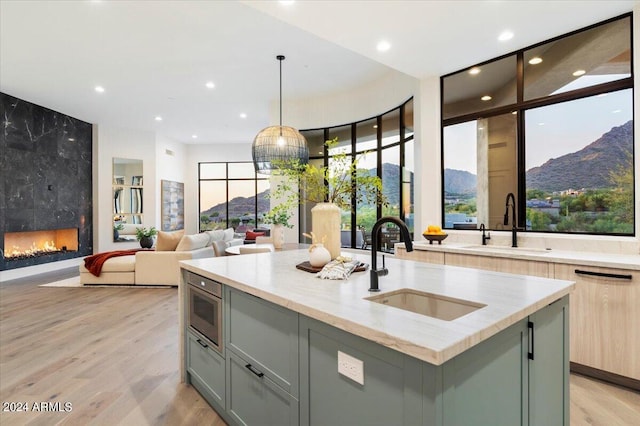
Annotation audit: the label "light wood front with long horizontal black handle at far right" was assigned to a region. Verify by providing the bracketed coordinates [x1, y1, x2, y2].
[555, 264, 640, 379]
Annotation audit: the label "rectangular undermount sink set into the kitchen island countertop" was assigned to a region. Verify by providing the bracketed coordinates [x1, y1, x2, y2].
[365, 288, 487, 321]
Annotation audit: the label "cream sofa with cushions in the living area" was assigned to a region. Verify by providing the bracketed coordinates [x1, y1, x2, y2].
[80, 228, 243, 286]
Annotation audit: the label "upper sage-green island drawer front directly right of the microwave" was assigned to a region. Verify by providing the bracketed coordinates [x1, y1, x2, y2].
[225, 289, 298, 396]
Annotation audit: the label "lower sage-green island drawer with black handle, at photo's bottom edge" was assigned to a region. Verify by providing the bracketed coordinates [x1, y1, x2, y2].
[227, 350, 299, 426]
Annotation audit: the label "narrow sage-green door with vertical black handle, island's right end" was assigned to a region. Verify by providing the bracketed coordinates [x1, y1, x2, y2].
[529, 296, 569, 426]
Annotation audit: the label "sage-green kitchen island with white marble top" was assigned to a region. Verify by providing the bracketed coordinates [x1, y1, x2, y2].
[180, 250, 573, 425]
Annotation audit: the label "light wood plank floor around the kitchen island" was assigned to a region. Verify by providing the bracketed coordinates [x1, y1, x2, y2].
[0, 270, 640, 426]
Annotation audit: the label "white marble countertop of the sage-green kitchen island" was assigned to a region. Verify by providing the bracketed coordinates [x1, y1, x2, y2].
[180, 250, 574, 365]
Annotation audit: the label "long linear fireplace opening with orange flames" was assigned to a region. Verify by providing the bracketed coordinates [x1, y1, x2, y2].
[4, 228, 78, 262]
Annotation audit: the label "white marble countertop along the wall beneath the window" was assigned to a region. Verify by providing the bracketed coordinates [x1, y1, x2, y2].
[396, 241, 640, 270]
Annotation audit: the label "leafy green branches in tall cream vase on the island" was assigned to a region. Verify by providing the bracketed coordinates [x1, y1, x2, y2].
[271, 138, 388, 259]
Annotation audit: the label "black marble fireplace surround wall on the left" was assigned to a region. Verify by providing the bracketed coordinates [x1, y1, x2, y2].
[0, 93, 93, 270]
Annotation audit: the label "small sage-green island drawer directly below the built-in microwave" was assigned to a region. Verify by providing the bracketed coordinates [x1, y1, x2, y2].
[187, 332, 225, 408]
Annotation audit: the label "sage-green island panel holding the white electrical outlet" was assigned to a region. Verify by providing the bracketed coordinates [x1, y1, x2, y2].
[300, 317, 422, 426]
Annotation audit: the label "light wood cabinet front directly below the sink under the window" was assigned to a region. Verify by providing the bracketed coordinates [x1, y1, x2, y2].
[444, 253, 551, 278]
